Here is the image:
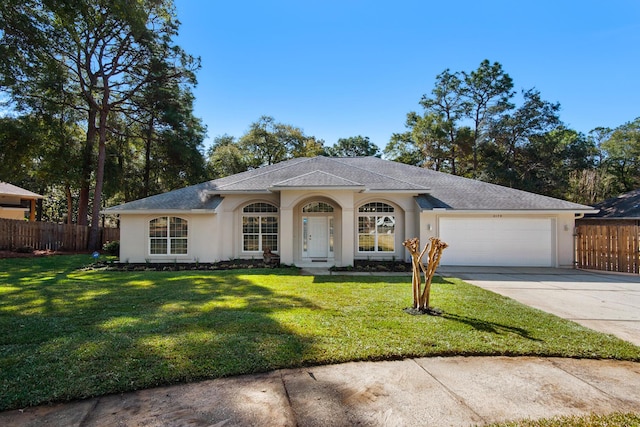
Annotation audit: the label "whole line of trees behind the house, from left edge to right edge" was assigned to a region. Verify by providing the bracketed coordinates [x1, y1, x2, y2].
[0, 0, 640, 229]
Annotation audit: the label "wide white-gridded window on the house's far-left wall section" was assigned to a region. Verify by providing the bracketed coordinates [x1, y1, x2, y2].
[149, 216, 189, 255]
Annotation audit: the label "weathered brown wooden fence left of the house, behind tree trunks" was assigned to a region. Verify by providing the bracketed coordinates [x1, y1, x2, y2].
[0, 218, 120, 251]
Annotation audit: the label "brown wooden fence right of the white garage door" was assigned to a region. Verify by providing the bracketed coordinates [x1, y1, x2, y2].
[576, 221, 640, 274]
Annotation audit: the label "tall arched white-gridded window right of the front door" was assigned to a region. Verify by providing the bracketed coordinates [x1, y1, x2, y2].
[358, 202, 396, 252]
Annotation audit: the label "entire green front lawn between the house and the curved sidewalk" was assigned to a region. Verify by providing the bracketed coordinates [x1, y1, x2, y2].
[0, 256, 640, 410]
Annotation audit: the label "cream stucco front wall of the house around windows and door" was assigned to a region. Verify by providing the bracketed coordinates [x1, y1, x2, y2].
[120, 197, 575, 267]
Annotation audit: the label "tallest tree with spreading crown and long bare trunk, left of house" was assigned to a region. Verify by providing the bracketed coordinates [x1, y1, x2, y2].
[0, 0, 195, 247]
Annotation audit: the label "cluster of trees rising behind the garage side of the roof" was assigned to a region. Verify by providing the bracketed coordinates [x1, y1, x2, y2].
[384, 60, 640, 204]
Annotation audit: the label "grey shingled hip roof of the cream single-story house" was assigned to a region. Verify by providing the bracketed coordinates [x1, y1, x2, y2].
[105, 156, 593, 213]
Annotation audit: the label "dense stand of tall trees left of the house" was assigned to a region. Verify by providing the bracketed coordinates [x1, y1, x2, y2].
[0, 0, 205, 234]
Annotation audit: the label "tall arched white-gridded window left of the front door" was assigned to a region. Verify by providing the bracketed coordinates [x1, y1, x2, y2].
[242, 202, 279, 252]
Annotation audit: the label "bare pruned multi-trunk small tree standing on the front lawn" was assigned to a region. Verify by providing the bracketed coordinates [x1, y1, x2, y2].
[402, 237, 449, 313]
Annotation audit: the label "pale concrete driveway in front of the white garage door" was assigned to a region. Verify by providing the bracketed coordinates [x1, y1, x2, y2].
[438, 266, 640, 345]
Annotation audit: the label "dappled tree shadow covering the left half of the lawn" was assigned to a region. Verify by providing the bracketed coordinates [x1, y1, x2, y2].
[0, 260, 316, 410]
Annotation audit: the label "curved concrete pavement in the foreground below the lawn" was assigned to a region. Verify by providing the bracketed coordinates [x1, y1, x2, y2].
[0, 357, 640, 427]
